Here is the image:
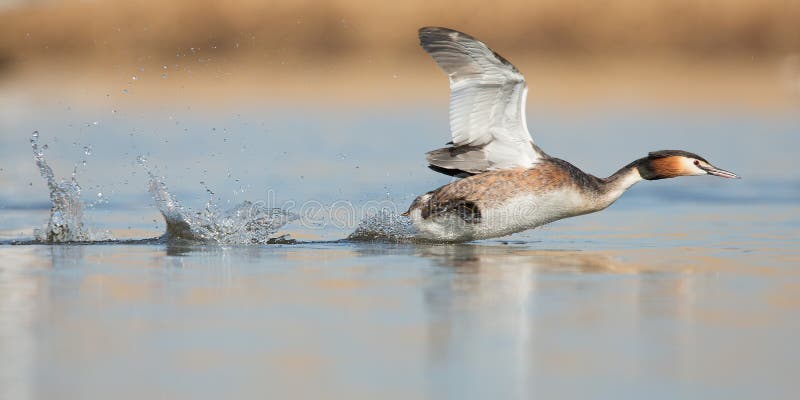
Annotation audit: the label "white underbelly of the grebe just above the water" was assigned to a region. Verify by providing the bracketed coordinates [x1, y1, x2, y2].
[409, 191, 588, 241]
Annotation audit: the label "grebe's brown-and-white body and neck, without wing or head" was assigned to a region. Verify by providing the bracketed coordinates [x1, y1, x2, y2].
[407, 157, 642, 241]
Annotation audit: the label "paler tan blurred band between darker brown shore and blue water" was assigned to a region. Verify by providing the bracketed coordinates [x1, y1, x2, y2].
[0, 51, 800, 112]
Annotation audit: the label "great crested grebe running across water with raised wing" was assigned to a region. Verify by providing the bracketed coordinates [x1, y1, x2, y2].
[403, 27, 738, 242]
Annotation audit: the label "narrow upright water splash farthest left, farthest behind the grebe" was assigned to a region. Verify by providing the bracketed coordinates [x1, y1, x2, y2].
[31, 131, 92, 243]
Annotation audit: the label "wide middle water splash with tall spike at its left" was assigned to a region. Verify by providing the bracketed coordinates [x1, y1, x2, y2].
[137, 156, 298, 245]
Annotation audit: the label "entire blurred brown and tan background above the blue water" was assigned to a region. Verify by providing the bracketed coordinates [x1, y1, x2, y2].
[0, 0, 800, 107]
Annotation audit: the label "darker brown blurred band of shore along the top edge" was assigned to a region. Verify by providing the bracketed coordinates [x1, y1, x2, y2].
[0, 0, 800, 65]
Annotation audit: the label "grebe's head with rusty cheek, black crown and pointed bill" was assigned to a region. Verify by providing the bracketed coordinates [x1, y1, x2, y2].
[638, 150, 739, 180]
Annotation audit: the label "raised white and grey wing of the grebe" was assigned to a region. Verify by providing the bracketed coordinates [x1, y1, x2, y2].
[419, 27, 545, 175]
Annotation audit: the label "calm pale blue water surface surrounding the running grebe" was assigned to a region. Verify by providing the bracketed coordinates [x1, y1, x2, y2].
[0, 101, 800, 399]
